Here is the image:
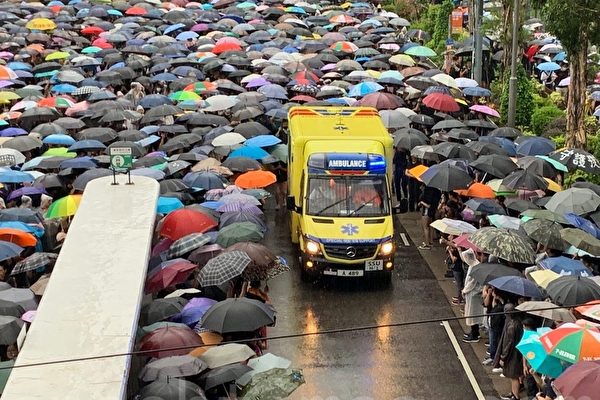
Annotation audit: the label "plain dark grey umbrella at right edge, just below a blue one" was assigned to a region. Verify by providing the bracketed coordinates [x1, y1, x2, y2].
[546, 276, 600, 307]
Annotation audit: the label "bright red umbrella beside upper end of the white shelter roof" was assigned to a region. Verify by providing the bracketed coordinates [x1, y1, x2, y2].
[160, 208, 218, 240]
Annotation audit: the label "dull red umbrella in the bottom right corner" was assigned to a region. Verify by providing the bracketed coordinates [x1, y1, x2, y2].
[552, 361, 600, 399]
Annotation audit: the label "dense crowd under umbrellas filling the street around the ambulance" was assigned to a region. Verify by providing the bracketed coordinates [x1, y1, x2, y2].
[0, 0, 600, 399]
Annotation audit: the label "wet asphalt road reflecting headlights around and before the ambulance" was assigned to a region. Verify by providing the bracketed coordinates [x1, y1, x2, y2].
[266, 210, 494, 400]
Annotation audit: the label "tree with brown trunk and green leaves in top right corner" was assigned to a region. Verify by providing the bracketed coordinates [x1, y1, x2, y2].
[534, 0, 600, 148]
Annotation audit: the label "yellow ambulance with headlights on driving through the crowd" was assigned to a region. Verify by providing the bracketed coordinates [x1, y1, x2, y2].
[287, 107, 395, 281]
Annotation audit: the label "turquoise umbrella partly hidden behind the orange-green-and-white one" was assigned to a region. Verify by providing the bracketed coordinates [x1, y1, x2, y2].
[517, 328, 568, 378]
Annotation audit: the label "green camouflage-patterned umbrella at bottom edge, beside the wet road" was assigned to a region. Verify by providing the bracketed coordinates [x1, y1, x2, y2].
[241, 368, 305, 400]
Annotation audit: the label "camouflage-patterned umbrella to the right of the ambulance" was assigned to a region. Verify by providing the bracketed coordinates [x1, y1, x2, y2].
[470, 227, 535, 264]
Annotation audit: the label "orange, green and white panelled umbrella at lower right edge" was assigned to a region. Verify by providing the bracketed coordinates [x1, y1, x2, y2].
[540, 320, 600, 364]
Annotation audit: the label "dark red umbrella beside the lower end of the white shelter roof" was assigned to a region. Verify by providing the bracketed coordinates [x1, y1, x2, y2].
[140, 326, 203, 358]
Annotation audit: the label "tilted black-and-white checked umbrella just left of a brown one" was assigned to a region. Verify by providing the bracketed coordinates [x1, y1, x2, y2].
[198, 251, 252, 287]
